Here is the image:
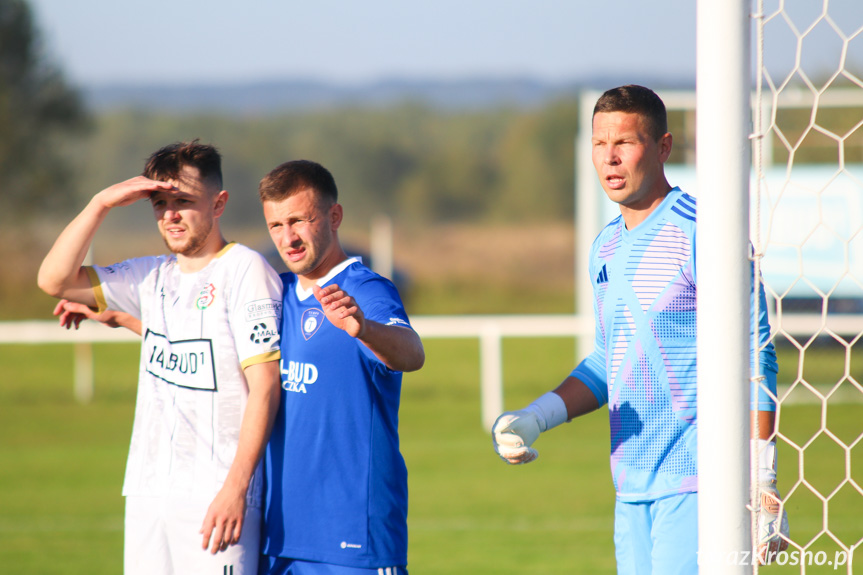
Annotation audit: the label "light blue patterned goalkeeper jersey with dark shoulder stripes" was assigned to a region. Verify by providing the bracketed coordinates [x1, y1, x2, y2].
[572, 188, 777, 502]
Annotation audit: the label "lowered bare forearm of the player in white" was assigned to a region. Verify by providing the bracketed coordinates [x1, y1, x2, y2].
[225, 361, 281, 494]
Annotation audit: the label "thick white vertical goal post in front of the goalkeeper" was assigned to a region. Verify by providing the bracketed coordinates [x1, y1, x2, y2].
[695, 0, 751, 575]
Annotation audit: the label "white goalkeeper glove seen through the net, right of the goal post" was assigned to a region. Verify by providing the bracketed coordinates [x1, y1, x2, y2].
[752, 439, 789, 565]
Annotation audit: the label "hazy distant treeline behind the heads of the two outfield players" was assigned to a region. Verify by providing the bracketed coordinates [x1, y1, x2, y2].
[74, 102, 578, 233]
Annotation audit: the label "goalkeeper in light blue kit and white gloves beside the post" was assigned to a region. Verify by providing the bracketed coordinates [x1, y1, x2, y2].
[492, 86, 788, 575]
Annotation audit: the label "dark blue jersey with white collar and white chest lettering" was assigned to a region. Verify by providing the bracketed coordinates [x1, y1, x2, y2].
[262, 259, 409, 568]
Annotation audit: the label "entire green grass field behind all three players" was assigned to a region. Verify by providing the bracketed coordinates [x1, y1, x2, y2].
[0, 338, 863, 575]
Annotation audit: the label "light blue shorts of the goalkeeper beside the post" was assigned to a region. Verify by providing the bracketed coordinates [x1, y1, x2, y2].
[614, 493, 698, 575]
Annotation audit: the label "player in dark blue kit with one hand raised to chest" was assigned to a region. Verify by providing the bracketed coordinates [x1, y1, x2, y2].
[259, 160, 425, 575]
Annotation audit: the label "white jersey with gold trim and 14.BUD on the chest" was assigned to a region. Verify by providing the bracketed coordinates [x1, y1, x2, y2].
[88, 243, 281, 506]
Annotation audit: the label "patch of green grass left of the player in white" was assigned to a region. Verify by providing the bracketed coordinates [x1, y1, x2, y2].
[0, 345, 137, 574]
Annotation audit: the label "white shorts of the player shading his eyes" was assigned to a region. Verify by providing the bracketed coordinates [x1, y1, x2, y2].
[123, 497, 261, 575]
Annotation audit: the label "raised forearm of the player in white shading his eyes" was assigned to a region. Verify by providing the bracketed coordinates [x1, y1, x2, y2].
[37, 195, 109, 305]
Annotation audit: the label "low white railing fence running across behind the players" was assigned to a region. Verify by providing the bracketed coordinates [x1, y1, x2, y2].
[0, 314, 852, 429]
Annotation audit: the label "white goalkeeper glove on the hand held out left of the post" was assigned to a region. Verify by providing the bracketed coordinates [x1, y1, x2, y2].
[491, 391, 567, 465]
